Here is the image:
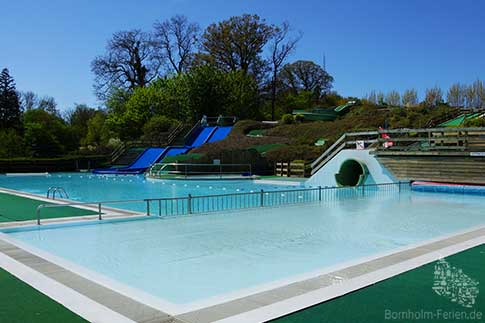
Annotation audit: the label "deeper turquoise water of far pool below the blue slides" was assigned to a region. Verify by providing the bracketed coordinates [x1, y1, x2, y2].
[0, 173, 294, 211]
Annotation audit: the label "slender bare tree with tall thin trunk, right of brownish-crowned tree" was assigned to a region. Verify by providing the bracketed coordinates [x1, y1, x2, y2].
[269, 21, 301, 120]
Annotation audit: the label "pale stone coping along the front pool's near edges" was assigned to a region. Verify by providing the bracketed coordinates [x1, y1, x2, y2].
[0, 226, 485, 323]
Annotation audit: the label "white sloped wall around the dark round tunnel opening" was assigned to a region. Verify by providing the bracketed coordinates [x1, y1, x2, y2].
[305, 149, 397, 187]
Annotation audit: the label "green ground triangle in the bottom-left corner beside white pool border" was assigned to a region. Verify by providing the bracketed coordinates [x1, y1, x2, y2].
[0, 269, 87, 323]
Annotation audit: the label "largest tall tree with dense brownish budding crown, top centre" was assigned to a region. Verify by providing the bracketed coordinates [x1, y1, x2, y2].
[199, 14, 275, 77]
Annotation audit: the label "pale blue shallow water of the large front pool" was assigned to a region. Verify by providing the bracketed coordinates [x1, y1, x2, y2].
[3, 191, 485, 304]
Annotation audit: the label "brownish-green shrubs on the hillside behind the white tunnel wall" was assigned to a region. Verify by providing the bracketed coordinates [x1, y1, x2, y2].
[192, 105, 455, 161]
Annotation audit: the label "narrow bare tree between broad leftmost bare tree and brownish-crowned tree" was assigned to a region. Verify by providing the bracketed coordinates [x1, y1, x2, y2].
[154, 15, 200, 74]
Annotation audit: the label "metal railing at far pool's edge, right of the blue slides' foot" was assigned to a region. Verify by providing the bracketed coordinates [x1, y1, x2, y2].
[148, 163, 252, 178]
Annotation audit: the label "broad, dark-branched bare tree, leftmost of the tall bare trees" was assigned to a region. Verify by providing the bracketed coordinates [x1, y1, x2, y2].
[91, 29, 162, 99]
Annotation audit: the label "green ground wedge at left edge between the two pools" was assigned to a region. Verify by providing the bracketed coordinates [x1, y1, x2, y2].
[0, 193, 96, 222]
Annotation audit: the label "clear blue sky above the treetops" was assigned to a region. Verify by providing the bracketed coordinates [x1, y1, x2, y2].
[0, 0, 485, 110]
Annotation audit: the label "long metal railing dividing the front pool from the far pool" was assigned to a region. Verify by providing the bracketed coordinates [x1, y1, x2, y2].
[36, 182, 411, 225]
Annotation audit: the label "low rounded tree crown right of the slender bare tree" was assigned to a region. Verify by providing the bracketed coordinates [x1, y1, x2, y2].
[279, 61, 333, 99]
